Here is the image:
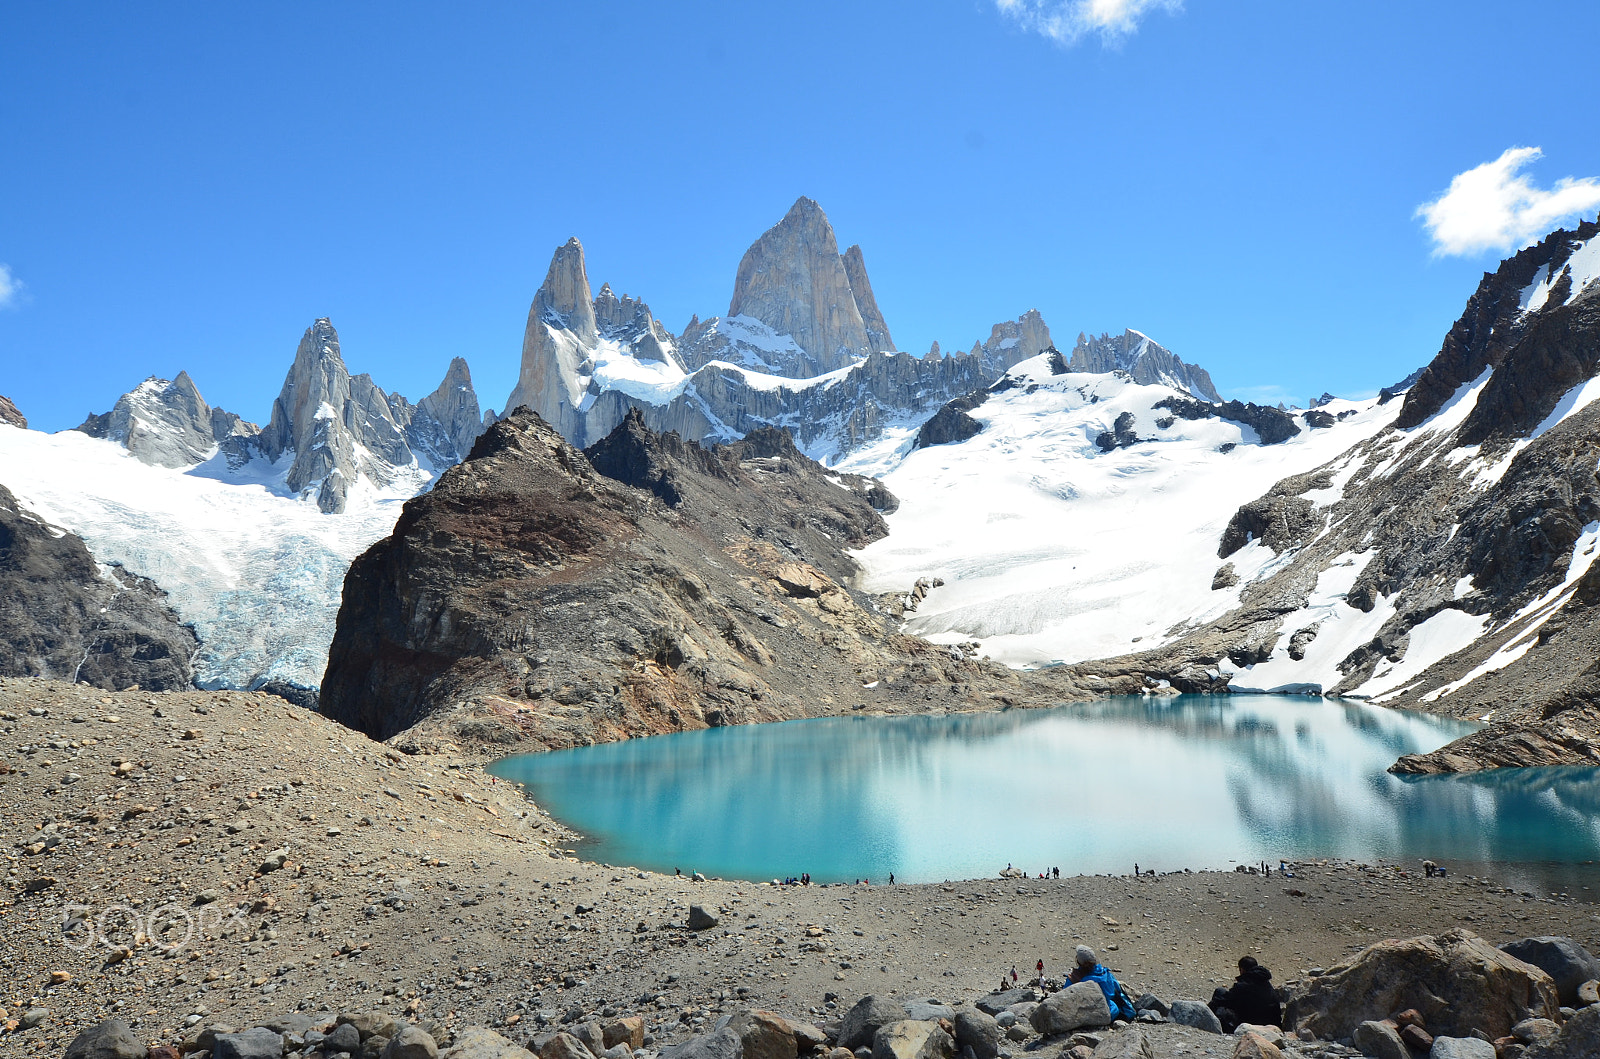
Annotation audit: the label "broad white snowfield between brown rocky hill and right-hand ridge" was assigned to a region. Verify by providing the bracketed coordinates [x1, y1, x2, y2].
[858, 352, 1398, 665]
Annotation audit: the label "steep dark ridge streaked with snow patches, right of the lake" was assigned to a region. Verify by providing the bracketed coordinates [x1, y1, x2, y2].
[1056, 222, 1600, 771]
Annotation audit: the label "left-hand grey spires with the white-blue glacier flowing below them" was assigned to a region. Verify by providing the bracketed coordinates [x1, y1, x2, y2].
[0, 320, 482, 688]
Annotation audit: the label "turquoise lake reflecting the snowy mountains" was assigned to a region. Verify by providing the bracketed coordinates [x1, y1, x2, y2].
[491, 696, 1600, 885]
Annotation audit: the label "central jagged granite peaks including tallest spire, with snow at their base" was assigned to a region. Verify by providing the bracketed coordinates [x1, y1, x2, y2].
[506, 198, 1218, 474]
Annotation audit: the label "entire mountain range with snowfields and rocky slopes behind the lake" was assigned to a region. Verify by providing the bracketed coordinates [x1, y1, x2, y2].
[0, 198, 1600, 771]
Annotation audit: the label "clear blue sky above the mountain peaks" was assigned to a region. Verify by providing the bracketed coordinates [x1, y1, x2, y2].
[0, 0, 1600, 429]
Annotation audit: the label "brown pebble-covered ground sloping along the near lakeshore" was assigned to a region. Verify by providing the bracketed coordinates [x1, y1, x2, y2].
[0, 680, 1600, 1056]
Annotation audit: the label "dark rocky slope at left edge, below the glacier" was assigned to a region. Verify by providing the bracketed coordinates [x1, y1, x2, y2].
[0, 486, 198, 691]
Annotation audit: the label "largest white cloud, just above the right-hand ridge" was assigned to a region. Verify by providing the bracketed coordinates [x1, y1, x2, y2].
[1416, 147, 1600, 258]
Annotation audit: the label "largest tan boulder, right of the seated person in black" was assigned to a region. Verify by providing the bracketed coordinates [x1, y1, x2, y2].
[1285, 929, 1560, 1040]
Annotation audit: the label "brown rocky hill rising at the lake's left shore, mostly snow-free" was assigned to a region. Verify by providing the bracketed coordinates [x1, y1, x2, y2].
[322, 410, 1018, 747]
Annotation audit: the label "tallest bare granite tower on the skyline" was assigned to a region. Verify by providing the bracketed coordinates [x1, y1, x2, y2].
[728, 198, 888, 379]
